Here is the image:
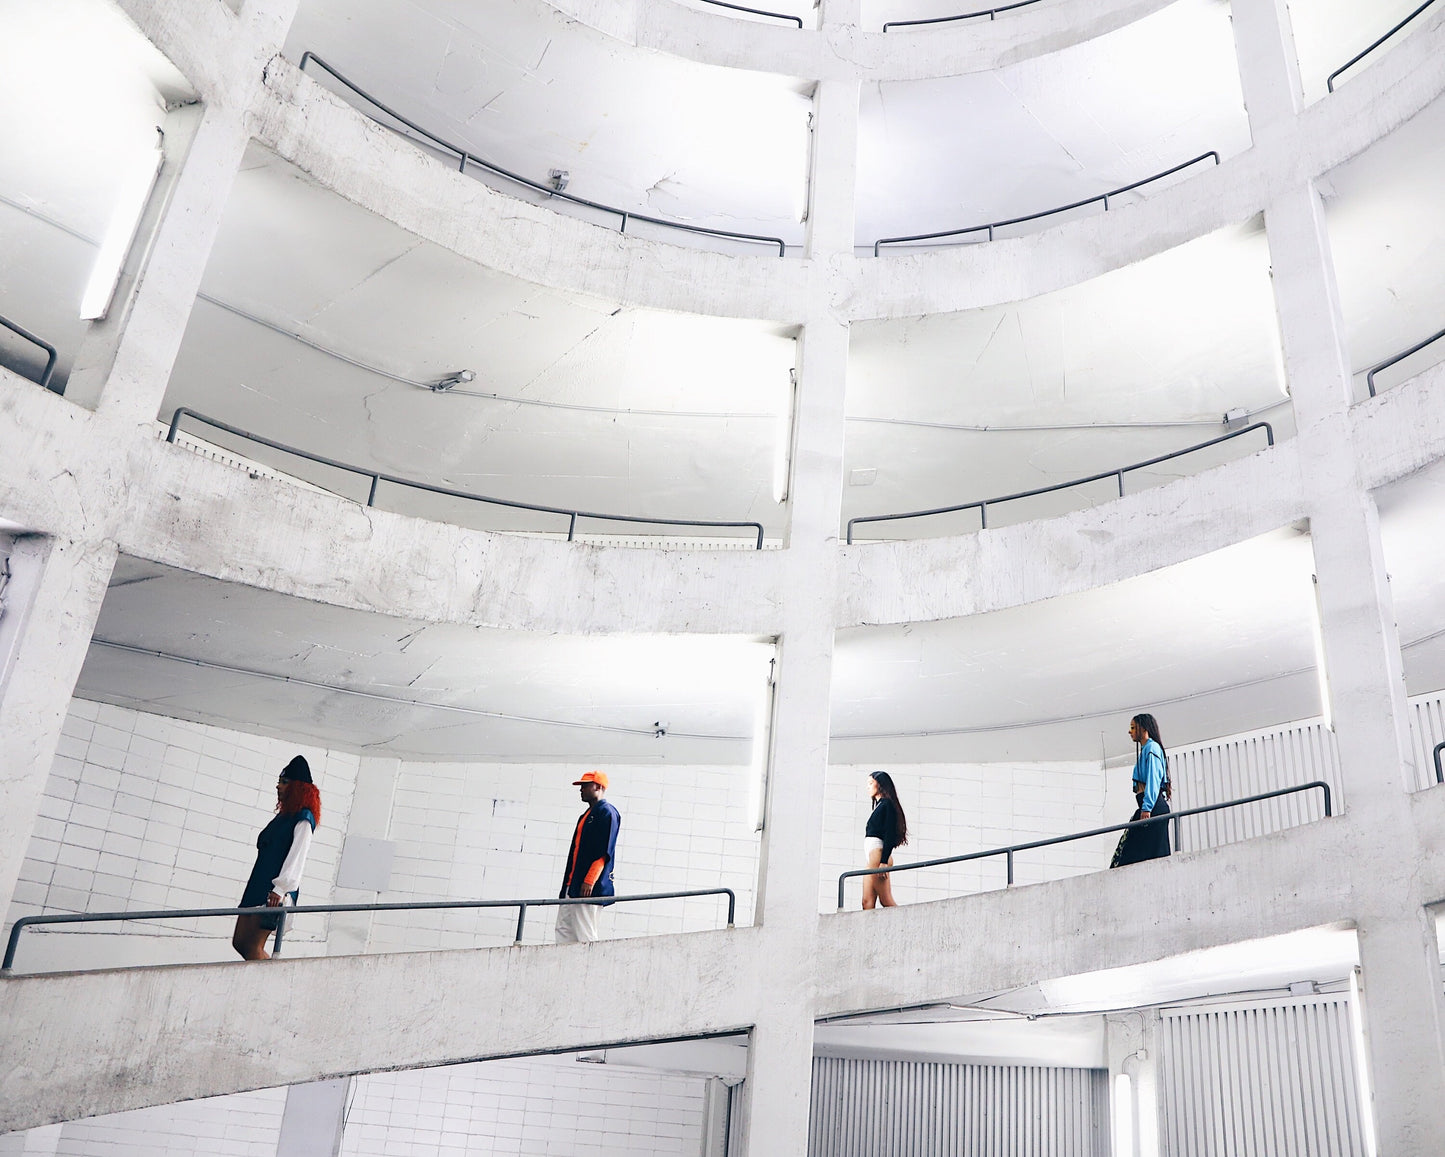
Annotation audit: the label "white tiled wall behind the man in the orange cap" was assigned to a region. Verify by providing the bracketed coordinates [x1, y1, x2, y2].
[371, 763, 757, 950]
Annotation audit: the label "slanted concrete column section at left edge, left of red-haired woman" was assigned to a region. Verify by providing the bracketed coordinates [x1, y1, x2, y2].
[0, 536, 116, 911]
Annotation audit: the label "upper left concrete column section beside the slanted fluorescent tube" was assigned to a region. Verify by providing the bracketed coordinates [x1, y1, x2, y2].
[65, 0, 299, 423]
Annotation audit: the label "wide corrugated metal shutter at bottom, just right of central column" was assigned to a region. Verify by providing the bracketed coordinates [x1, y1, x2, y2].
[808, 1057, 1108, 1157]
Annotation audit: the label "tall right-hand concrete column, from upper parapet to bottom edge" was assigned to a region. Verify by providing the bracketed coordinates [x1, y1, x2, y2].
[1266, 183, 1445, 1157]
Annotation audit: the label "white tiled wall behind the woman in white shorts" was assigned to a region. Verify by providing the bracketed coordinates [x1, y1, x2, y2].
[818, 763, 1109, 911]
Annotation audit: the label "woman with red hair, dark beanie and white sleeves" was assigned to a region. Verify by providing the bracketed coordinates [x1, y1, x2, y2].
[231, 755, 321, 961]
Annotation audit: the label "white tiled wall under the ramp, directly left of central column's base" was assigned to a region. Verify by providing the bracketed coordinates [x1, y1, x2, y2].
[341, 1057, 705, 1157]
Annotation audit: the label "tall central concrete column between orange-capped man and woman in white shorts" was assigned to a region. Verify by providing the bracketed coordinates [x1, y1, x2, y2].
[746, 20, 858, 1157]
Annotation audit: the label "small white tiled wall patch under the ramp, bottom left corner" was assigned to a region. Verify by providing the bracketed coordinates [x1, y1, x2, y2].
[39, 1089, 286, 1157]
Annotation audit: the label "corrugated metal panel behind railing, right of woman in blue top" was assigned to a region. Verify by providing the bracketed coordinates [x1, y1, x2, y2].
[1169, 721, 1342, 852]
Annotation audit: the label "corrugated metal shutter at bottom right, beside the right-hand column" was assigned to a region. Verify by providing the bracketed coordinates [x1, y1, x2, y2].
[1159, 994, 1366, 1157]
